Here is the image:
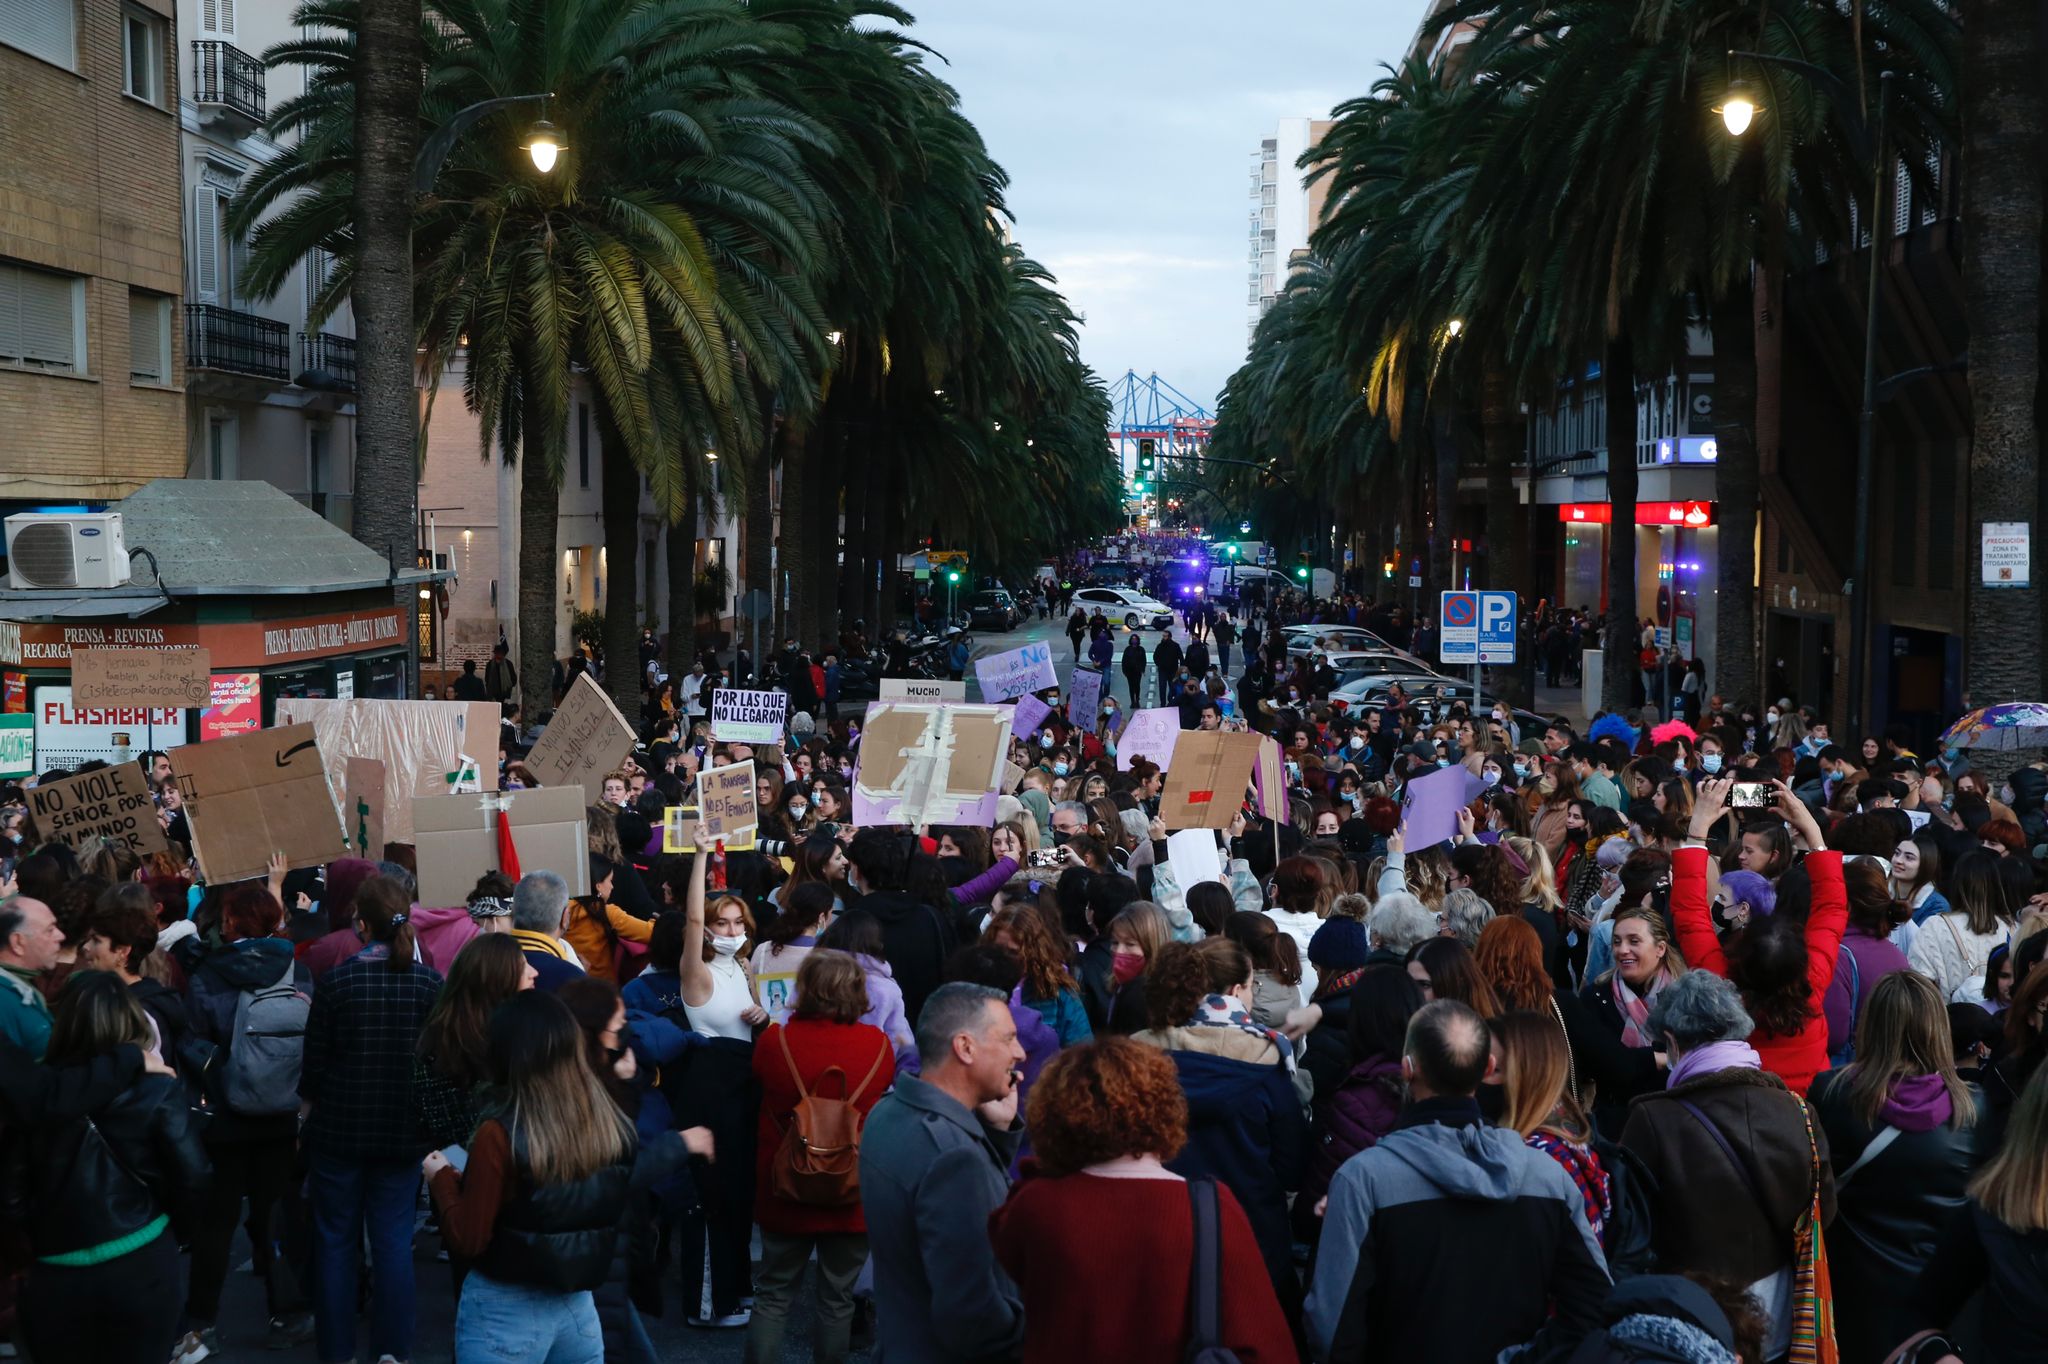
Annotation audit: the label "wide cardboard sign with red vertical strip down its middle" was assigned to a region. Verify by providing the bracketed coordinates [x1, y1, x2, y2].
[412, 784, 590, 907]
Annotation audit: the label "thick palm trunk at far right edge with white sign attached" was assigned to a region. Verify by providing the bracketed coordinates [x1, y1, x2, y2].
[1957, 0, 2042, 753]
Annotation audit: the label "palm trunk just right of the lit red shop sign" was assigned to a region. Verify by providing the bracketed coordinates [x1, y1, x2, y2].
[1708, 276, 1761, 700]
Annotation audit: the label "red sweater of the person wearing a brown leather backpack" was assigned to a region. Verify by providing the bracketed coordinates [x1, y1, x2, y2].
[754, 1016, 895, 1237]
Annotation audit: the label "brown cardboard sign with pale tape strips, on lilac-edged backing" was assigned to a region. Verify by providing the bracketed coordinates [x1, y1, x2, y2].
[854, 700, 1012, 827]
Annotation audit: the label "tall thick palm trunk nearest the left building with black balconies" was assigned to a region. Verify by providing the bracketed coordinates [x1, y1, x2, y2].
[350, 0, 420, 666]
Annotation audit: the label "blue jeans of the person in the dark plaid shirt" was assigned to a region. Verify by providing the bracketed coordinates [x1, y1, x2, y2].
[307, 1153, 420, 1364]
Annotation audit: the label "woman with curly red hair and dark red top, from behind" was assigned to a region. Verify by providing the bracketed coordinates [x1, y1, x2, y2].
[989, 1036, 1296, 1364]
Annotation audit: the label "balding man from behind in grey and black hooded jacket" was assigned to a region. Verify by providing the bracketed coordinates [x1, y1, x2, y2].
[1305, 995, 1610, 1360]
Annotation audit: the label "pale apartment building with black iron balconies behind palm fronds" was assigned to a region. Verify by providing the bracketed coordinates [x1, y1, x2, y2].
[176, 0, 356, 530]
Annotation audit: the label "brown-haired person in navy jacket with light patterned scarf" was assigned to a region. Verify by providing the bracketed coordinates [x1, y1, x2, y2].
[1133, 938, 1307, 1319]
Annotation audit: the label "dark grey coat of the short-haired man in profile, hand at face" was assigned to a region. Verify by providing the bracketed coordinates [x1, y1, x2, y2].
[860, 1075, 1024, 1364]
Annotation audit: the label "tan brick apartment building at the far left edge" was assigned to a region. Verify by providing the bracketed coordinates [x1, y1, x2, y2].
[0, 0, 186, 499]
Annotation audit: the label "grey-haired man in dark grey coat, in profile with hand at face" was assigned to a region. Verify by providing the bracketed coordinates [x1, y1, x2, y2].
[860, 981, 1024, 1364]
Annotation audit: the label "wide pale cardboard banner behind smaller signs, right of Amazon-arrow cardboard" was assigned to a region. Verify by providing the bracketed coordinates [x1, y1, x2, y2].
[274, 696, 502, 844]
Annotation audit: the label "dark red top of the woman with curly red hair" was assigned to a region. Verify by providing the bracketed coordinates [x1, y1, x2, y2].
[989, 1161, 1298, 1364]
